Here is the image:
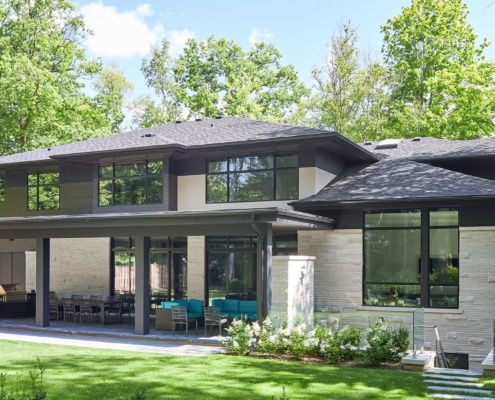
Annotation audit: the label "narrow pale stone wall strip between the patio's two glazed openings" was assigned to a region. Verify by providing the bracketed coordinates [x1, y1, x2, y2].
[187, 236, 206, 300]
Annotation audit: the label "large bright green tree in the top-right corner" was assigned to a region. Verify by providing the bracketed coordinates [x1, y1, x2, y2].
[382, 0, 495, 139]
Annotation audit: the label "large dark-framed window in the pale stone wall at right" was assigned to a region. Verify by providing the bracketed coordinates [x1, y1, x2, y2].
[363, 207, 459, 308]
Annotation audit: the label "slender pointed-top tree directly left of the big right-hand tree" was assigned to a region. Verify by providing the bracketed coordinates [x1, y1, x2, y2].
[290, 21, 387, 142]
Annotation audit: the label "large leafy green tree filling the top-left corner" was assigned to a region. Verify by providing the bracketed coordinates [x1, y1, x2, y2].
[0, 0, 109, 154]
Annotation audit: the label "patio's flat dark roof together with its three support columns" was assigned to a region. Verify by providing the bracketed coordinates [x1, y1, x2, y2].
[0, 208, 334, 335]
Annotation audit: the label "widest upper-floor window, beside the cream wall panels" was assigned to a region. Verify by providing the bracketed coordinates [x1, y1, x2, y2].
[206, 154, 299, 203]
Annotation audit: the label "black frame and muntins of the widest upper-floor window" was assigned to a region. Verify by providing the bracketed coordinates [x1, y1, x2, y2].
[205, 152, 300, 204]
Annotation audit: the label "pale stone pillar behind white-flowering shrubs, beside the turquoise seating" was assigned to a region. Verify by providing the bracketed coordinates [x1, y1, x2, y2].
[268, 256, 314, 326]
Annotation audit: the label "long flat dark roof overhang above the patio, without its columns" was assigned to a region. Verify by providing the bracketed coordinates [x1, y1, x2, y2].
[0, 208, 335, 239]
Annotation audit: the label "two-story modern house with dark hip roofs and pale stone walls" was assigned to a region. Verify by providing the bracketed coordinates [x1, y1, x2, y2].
[0, 117, 495, 363]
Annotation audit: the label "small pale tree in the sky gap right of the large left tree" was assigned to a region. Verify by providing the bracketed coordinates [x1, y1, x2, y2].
[93, 63, 134, 133]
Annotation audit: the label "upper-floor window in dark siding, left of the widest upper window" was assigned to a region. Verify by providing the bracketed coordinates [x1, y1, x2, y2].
[98, 161, 163, 206]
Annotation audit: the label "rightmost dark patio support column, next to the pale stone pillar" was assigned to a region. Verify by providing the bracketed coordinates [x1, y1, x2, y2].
[256, 224, 272, 321]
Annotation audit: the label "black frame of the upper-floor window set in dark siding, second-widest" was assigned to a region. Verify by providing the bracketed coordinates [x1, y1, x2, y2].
[97, 159, 164, 207]
